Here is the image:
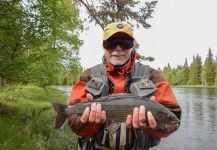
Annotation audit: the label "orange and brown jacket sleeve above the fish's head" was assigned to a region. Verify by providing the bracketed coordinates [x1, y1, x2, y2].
[146, 69, 181, 138]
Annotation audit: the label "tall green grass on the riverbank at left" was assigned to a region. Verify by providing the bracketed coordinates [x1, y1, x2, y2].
[0, 86, 76, 150]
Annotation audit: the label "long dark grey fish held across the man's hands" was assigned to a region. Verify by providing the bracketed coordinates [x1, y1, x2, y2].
[53, 94, 180, 133]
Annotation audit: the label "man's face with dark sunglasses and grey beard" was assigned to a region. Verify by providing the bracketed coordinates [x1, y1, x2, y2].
[103, 35, 134, 66]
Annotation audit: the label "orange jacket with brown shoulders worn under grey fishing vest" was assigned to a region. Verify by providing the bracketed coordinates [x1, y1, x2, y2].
[69, 54, 181, 138]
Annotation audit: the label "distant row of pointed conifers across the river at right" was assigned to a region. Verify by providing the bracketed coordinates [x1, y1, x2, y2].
[161, 48, 217, 86]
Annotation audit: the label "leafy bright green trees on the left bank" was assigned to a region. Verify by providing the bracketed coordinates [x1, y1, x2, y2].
[0, 0, 82, 87]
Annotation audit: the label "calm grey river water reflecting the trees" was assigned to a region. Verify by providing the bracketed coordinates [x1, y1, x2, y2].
[58, 88, 217, 150]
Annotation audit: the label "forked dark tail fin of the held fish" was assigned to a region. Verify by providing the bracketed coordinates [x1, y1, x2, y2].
[52, 102, 68, 129]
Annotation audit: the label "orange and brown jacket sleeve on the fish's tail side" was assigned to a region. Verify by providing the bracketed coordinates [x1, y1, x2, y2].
[68, 70, 100, 136]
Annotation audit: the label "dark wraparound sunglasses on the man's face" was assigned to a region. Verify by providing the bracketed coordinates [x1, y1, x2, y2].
[103, 38, 133, 50]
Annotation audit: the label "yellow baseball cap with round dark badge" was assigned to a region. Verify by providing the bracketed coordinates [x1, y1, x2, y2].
[103, 22, 134, 41]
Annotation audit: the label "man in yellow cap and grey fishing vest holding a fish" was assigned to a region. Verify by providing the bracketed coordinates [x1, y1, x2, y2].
[69, 22, 181, 149]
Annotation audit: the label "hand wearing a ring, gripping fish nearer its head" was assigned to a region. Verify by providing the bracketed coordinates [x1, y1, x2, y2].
[126, 105, 157, 129]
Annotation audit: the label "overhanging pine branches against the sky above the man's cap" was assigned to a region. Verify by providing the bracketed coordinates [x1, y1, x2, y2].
[74, 0, 157, 29]
